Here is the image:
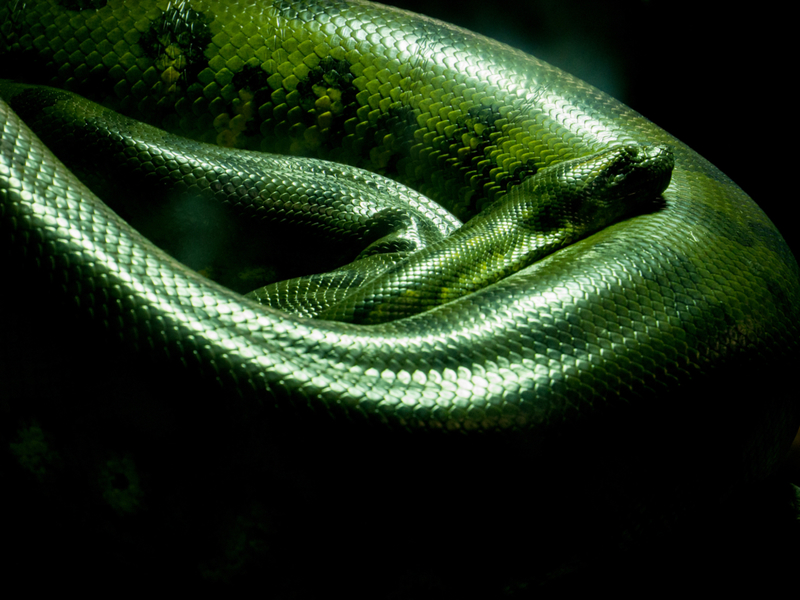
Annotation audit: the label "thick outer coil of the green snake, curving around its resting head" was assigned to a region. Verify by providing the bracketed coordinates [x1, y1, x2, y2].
[0, 0, 800, 592]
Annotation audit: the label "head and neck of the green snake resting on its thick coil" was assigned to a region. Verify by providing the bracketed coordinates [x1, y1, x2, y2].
[314, 146, 673, 325]
